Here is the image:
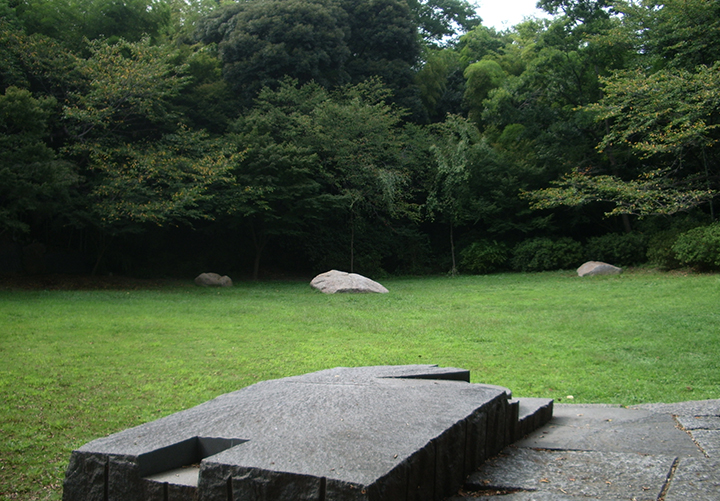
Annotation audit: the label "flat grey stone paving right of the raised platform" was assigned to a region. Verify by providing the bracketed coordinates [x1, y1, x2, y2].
[449, 400, 720, 501]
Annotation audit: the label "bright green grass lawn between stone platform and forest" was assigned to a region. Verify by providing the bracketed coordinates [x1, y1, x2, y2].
[0, 272, 720, 500]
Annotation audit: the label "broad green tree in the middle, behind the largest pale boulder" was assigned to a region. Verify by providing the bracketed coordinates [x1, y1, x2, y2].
[219, 79, 414, 275]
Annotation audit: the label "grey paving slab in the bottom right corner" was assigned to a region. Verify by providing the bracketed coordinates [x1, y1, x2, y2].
[665, 458, 720, 501]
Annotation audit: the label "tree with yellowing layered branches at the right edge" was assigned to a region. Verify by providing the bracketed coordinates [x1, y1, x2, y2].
[532, 0, 720, 218]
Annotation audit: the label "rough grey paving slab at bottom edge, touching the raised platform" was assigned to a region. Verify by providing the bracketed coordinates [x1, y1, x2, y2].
[465, 446, 675, 501]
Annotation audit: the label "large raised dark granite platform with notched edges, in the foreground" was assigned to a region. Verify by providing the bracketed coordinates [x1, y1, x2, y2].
[63, 365, 553, 501]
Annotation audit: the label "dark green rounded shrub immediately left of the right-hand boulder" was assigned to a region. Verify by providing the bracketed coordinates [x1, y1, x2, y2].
[512, 238, 583, 271]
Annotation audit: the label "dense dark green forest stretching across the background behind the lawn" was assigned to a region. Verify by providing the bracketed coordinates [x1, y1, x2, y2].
[0, 0, 720, 278]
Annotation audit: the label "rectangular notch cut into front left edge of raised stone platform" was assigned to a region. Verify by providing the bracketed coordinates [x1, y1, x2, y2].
[138, 437, 247, 477]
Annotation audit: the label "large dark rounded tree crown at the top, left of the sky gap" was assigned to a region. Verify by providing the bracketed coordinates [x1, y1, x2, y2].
[197, 0, 424, 120]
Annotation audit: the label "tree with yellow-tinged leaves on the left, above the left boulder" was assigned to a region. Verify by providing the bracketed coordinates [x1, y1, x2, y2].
[64, 39, 236, 269]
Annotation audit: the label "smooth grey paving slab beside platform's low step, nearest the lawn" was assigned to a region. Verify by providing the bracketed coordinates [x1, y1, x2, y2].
[516, 404, 703, 457]
